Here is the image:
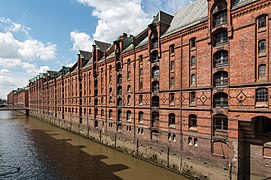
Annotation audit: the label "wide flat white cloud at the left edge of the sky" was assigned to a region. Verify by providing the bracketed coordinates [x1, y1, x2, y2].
[0, 32, 56, 61]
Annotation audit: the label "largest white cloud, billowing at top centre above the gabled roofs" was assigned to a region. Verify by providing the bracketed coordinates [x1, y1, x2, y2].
[77, 0, 151, 43]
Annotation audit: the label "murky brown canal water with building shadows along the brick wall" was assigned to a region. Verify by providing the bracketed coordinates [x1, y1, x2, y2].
[0, 111, 186, 180]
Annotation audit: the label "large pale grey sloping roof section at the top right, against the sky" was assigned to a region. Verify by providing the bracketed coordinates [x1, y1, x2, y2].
[165, 0, 208, 35]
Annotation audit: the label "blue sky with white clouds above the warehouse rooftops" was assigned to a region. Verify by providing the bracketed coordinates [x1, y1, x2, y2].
[0, 0, 193, 99]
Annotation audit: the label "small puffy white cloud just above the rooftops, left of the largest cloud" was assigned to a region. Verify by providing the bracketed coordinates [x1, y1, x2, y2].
[70, 31, 93, 51]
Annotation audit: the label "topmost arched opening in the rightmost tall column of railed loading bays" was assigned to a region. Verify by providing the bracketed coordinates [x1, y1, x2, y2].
[212, 0, 227, 27]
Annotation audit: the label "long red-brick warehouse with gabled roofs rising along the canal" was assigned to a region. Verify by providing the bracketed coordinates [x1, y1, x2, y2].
[7, 0, 271, 179]
